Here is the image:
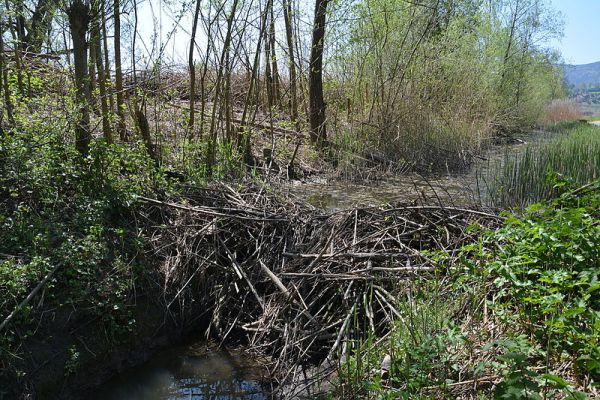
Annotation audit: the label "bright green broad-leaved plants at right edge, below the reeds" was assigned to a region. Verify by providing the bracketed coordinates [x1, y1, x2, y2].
[482, 183, 600, 381]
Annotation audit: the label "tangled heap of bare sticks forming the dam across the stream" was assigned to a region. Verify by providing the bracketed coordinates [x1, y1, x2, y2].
[140, 185, 501, 396]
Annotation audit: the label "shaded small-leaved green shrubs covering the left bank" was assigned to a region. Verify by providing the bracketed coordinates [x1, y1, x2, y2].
[0, 122, 172, 372]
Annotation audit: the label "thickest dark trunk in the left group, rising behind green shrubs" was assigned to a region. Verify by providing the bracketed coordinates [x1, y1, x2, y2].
[67, 0, 91, 156]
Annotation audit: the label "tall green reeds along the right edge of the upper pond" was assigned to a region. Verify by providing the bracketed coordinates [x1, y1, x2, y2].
[480, 123, 600, 207]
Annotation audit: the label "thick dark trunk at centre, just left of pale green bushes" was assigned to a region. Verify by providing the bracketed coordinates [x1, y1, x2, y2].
[308, 0, 329, 146]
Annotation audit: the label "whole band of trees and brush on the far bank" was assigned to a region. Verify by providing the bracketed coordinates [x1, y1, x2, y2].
[0, 0, 566, 176]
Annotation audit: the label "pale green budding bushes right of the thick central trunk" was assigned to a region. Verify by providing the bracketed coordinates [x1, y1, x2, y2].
[325, 0, 566, 172]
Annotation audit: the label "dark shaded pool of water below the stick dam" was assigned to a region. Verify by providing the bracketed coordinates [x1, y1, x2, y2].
[91, 343, 270, 400]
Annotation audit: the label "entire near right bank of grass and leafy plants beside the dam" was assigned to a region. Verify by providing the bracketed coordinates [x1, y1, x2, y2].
[337, 181, 600, 399]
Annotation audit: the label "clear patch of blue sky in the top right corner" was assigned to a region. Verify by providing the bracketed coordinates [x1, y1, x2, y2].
[552, 0, 600, 64]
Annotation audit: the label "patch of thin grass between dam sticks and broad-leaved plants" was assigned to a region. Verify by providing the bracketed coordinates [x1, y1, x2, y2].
[339, 280, 470, 399]
